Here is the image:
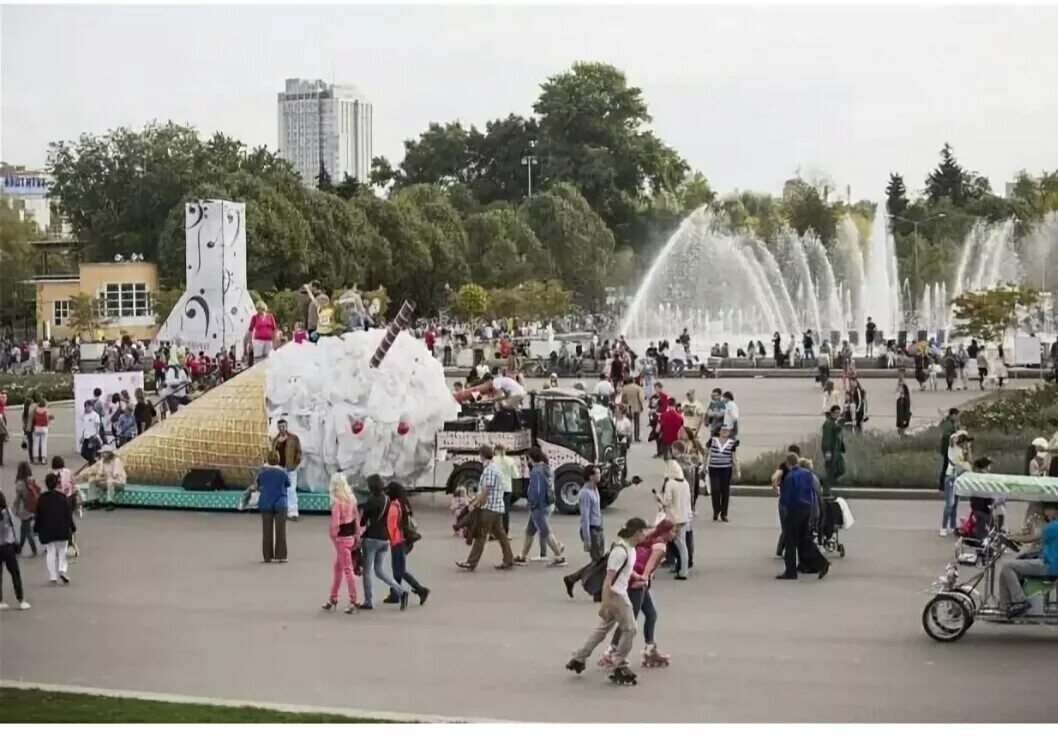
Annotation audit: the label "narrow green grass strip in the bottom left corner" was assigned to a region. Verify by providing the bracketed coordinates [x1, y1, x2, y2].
[0, 688, 387, 723]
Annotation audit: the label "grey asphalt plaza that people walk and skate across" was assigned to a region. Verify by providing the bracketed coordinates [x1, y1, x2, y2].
[0, 380, 1058, 721]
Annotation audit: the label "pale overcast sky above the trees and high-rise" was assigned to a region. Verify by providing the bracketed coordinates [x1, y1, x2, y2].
[0, 5, 1058, 199]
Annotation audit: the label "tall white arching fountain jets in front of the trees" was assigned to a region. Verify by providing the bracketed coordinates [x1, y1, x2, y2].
[621, 199, 1058, 348]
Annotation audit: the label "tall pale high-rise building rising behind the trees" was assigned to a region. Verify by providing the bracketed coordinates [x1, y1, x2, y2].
[278, 79, 373, 185]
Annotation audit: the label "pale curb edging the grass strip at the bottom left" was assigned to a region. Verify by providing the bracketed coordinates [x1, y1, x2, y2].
[0, 679, 486, 723]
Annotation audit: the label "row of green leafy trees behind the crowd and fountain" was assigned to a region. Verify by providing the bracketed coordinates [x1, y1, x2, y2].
[0, 62, 1058, 329]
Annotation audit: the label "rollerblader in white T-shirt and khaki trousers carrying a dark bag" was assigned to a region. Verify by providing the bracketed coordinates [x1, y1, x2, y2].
[566, 518, 647, 685]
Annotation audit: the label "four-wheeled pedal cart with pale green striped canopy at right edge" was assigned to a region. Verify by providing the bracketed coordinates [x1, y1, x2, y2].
[922, 472, 1058, 643]
